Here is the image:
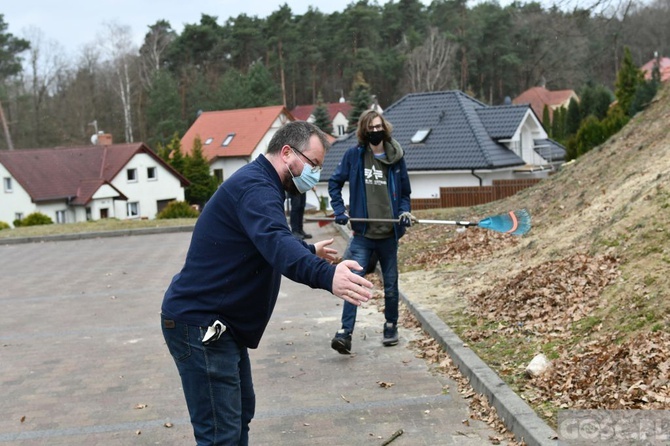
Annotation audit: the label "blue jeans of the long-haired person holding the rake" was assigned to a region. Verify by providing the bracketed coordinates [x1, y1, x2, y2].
[342, 235, 398, 333]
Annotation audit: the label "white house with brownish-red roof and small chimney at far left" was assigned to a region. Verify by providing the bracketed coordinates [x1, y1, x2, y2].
[0, 139, 189, 225]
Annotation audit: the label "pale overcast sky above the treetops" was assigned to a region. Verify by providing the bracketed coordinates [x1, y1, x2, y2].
[0, 0, 430, 56]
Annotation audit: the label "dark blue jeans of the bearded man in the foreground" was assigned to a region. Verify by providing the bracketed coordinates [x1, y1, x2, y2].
[161, 316, 256, 446]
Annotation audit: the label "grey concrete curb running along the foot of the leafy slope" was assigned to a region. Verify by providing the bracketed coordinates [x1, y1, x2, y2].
[335, 225, 558, 446]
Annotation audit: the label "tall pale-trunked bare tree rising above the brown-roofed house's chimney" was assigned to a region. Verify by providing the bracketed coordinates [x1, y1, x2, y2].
[100, 22, 137, 142]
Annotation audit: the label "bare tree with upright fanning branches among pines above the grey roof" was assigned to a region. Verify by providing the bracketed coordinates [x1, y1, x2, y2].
[406, 28, 456, 93]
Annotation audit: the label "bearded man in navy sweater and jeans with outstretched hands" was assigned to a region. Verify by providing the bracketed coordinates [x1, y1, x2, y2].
[161, 121, 372, 445]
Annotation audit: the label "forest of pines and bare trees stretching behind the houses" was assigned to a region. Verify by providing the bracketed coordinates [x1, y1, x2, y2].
[0, 0, 670, 149]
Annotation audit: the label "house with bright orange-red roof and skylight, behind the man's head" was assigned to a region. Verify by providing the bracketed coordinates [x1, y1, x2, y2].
[181, 105, 295, 182]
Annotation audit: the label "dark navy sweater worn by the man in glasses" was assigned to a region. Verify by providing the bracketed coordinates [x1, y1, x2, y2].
[161, 155, 335, 348]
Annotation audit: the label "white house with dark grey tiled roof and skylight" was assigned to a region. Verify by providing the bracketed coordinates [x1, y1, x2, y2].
[322, 90, 565, 211]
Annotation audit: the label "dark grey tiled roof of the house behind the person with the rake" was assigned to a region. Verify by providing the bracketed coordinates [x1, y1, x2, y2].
[321, 90, 560, 181]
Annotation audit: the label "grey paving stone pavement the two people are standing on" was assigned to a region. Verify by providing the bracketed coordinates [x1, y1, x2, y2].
[0, 223, 510, 446]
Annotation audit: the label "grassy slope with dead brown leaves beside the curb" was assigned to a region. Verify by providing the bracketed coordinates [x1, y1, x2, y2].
[400, 85, 670, 422]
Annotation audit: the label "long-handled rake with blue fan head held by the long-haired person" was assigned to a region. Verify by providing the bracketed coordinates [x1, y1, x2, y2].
[305, 209, 530, 235]
